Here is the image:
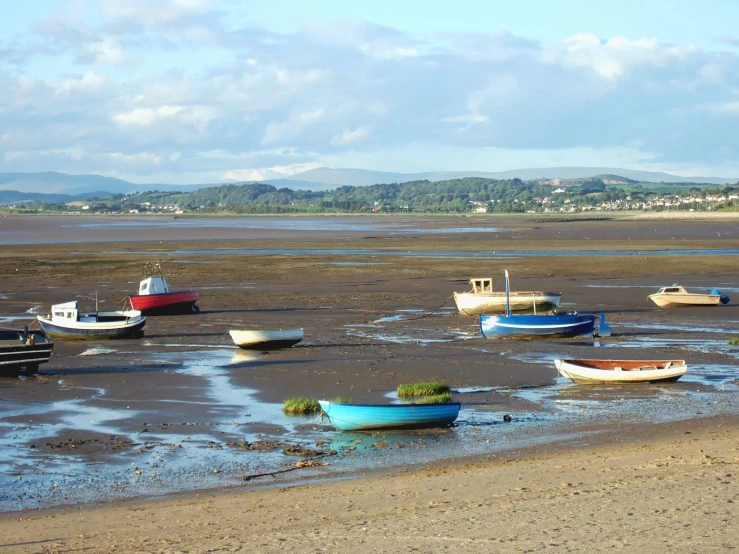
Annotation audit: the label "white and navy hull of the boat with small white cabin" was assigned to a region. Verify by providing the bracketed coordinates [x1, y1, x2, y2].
[36, 312, 146, 340]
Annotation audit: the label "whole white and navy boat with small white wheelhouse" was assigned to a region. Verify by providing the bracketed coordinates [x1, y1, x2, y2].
[36, 301, 146, 340]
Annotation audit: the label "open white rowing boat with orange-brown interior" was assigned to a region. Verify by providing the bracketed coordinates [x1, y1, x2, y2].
[554, 360, 688, 385]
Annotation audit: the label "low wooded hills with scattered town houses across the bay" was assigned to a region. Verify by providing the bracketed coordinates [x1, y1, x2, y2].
[4, 175, 739, 215]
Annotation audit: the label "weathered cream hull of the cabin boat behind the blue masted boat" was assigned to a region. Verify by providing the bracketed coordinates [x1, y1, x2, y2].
[454, 291, 562, 316]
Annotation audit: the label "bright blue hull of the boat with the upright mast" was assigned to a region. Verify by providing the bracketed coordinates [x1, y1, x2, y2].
[480, 314, 596, 339]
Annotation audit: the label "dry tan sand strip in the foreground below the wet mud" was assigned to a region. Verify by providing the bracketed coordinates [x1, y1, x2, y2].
[0, 419, 739, 553]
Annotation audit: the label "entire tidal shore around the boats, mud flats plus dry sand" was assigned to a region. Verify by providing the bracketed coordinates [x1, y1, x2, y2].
[0, 216, 739, 553]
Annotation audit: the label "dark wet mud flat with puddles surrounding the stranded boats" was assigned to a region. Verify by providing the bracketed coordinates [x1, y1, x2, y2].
[0, 213, 739, 511]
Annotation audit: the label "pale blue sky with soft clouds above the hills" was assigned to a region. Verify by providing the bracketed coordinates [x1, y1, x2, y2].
[0, 0, 739, 184]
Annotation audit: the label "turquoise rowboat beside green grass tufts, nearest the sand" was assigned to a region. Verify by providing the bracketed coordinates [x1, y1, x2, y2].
[318, 400, 461, 431]
